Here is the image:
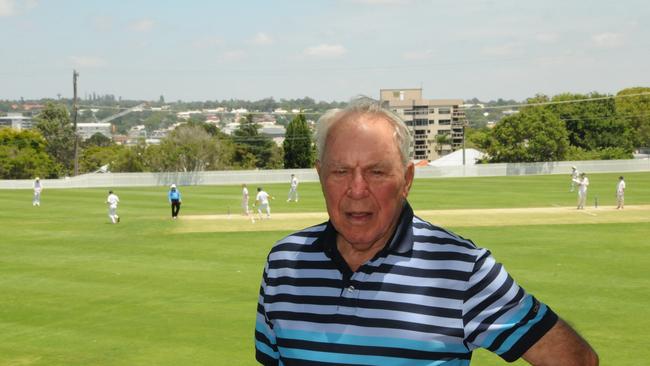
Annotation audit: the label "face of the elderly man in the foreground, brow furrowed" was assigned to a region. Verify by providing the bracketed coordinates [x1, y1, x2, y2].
[317, 115, 413, 252]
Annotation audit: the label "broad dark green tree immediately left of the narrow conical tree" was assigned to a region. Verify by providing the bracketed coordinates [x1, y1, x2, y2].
[233, 114, 282, 169]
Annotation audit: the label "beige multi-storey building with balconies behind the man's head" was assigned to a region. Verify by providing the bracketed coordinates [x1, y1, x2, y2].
[379, 89, 466, 161]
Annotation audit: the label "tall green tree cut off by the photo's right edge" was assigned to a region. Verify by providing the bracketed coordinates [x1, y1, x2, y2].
[615, 88, 650, 147]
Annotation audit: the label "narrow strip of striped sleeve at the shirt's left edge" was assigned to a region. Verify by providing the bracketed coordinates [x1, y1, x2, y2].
[255, 262, 279, 365]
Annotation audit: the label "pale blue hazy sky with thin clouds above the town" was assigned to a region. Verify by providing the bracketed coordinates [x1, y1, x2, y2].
[0, 0, 650, 101]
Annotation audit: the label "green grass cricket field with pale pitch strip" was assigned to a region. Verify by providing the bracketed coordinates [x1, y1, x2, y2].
[0, 173, 650, 366]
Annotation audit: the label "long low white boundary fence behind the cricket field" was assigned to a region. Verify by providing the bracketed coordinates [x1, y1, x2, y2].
[0, 159, 650, 189]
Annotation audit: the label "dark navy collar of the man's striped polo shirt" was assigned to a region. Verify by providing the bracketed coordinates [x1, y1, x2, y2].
[314, 201, 413, 258]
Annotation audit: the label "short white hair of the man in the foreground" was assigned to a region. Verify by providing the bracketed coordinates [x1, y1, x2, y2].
[316, 96, 411, 166]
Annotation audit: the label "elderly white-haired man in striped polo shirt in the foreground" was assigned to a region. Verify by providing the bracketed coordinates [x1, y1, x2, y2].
[255, 100, 598, 366]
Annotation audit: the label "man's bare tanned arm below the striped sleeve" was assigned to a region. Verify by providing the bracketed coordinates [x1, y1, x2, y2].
[522, 319, 598, 366]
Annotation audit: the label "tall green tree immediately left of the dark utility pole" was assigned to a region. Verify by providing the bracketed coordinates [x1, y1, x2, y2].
[35, 102, 76, 174]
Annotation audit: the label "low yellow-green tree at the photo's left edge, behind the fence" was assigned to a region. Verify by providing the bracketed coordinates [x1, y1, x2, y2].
[0, 128, 61, 179]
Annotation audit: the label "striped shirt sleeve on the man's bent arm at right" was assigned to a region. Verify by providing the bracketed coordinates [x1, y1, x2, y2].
[463, 249, 558, 362]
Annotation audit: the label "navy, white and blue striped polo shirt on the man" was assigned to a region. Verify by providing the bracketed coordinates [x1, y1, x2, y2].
[255, 203, 557, 365]
